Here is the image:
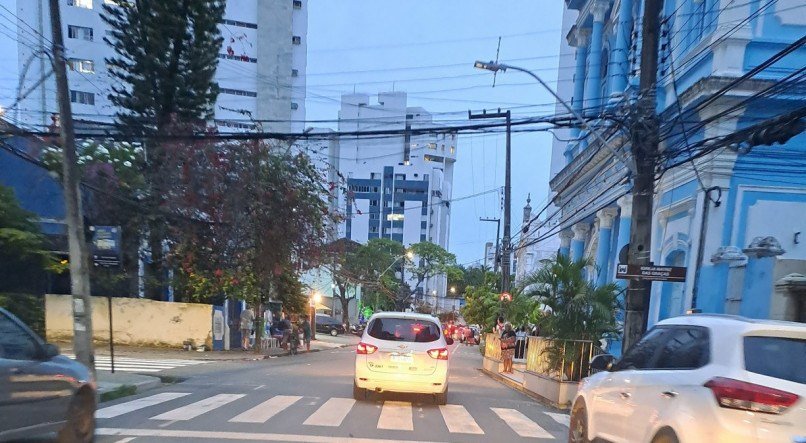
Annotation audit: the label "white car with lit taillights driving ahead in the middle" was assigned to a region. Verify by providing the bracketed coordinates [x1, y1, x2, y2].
[353, 312, 453, 405]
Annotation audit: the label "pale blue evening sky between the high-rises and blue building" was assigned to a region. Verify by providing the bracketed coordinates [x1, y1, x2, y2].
[306, 0, 567, 263]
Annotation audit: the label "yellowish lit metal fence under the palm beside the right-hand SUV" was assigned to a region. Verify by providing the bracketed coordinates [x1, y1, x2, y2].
[524, 337, 603, 381]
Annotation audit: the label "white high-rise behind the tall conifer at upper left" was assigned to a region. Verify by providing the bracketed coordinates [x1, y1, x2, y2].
[0, 0, 308, 132]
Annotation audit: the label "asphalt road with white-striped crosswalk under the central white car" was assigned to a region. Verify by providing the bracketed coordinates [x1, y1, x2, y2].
[83, 346, 567, 443]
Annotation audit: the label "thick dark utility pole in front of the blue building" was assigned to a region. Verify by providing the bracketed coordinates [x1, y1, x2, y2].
[622, 0, 663, 351]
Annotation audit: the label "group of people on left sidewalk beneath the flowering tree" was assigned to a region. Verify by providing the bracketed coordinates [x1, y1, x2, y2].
[240, 307, 312, 353]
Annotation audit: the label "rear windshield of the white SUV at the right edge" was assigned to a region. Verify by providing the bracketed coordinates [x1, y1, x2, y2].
[744, 336, 806, 384]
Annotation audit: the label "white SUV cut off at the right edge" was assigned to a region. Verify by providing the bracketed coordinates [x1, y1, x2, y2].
[568, 314, 806, 443]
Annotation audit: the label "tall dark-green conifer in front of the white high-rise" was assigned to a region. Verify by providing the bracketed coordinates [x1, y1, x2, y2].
[102, 0, 225, 299]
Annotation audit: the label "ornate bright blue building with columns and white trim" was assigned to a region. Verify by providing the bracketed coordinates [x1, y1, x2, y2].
[550, 0, 806, 350]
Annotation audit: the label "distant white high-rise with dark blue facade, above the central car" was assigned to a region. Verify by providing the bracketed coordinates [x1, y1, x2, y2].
[332, 92, 457, 305]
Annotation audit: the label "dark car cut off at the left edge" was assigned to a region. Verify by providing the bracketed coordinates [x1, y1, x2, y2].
[0, 308, 97, 442]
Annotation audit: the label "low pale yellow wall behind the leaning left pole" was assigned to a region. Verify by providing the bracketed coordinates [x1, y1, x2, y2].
[45, 294, 212, 347]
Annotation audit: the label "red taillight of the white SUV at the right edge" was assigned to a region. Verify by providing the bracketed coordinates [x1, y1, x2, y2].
[705, 377, 799, 414]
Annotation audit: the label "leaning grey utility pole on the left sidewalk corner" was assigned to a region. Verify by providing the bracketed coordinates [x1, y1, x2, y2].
[50, 0, 95, 372]
